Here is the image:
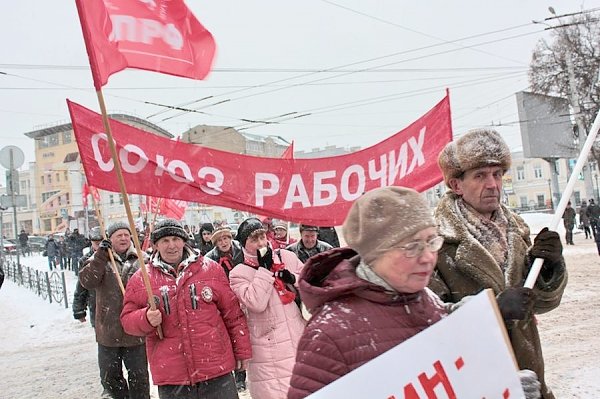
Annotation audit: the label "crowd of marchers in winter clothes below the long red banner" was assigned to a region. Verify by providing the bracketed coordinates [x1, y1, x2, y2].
[65, 130, 572, 399]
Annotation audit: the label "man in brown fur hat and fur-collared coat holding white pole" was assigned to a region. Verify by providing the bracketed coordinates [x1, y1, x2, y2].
[430, 129, 567, 399]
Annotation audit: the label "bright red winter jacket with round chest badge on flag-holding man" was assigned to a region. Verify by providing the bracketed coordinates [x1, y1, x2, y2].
[121, 249, 252, 385]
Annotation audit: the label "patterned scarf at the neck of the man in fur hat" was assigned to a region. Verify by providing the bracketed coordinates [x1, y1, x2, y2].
[456, 197, 508, 271]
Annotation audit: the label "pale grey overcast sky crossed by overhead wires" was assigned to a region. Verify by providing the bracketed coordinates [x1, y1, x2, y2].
[0, 0, 600, 175]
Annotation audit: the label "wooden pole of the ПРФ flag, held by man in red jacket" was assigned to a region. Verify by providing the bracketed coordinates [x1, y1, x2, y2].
[96, 89, 163, 339]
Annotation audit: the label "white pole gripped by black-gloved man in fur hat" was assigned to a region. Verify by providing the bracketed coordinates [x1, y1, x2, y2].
[524, 108, 600, 288]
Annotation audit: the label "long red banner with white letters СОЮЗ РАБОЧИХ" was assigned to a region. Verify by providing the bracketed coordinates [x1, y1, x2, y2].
[67, 96, 452, 226]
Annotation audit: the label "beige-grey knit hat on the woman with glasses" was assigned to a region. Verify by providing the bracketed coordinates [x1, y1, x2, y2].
[343, 187, 436, 264]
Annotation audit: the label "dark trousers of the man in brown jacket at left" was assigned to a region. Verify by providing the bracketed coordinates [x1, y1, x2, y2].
[98, 344, 150, 399]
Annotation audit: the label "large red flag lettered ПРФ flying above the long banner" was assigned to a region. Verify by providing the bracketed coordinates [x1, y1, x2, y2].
[75, 0, 215, 90]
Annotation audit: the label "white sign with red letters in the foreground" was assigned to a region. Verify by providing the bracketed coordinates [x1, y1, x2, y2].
[308, 290, 525, 399]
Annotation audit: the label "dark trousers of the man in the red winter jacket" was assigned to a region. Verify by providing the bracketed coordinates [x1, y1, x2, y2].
[158, 373, 239, 399]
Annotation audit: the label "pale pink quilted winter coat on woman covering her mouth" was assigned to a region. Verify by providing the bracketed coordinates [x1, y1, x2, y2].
[229, 249, 305, 399]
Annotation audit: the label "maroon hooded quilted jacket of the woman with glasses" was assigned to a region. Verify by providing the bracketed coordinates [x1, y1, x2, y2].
[288, 248, 446, 399]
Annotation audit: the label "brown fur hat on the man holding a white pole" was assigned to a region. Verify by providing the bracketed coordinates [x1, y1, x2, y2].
[438, 129, 511, 187]
